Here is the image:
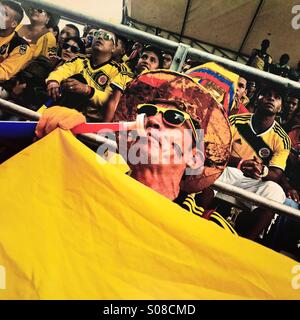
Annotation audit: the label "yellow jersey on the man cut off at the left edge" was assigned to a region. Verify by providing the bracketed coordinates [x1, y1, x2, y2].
[0, 32, 32, 81]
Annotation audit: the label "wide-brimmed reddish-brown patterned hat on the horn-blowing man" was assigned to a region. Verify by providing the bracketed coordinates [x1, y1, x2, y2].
[114, 70, 231, 193]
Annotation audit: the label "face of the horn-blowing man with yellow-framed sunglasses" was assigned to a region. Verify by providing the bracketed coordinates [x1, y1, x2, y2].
[131, 103, 198, 171]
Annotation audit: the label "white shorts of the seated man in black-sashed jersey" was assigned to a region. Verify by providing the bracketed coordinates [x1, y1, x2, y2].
[217, 167, 286, 211]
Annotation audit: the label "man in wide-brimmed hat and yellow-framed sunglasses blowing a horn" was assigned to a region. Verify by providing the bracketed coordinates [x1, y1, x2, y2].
[36, 71, 235, 233]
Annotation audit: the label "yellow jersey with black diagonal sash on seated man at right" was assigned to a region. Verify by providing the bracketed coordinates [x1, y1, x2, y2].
[229, 113, 291, 170]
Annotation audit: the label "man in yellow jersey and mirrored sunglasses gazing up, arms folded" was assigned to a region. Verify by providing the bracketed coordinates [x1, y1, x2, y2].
[46, 29, 131, 117]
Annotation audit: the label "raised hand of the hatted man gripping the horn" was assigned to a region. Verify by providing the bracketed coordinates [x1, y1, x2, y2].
[35, 107, 86, 138]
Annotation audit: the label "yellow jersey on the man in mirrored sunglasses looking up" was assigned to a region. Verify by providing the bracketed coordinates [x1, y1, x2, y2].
[46, 55, 131, 106]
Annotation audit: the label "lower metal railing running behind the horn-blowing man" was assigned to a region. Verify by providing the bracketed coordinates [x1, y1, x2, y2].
[0, 99, 300, 218]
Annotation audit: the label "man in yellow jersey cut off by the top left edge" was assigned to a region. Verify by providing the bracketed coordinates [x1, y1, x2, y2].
[0, 1, 33, 81]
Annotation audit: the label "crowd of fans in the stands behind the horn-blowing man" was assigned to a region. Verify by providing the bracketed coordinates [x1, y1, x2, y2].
[0, 1, 300, 258]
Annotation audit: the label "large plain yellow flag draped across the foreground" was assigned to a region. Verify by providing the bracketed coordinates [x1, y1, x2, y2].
[0, 129, 300, 299]
